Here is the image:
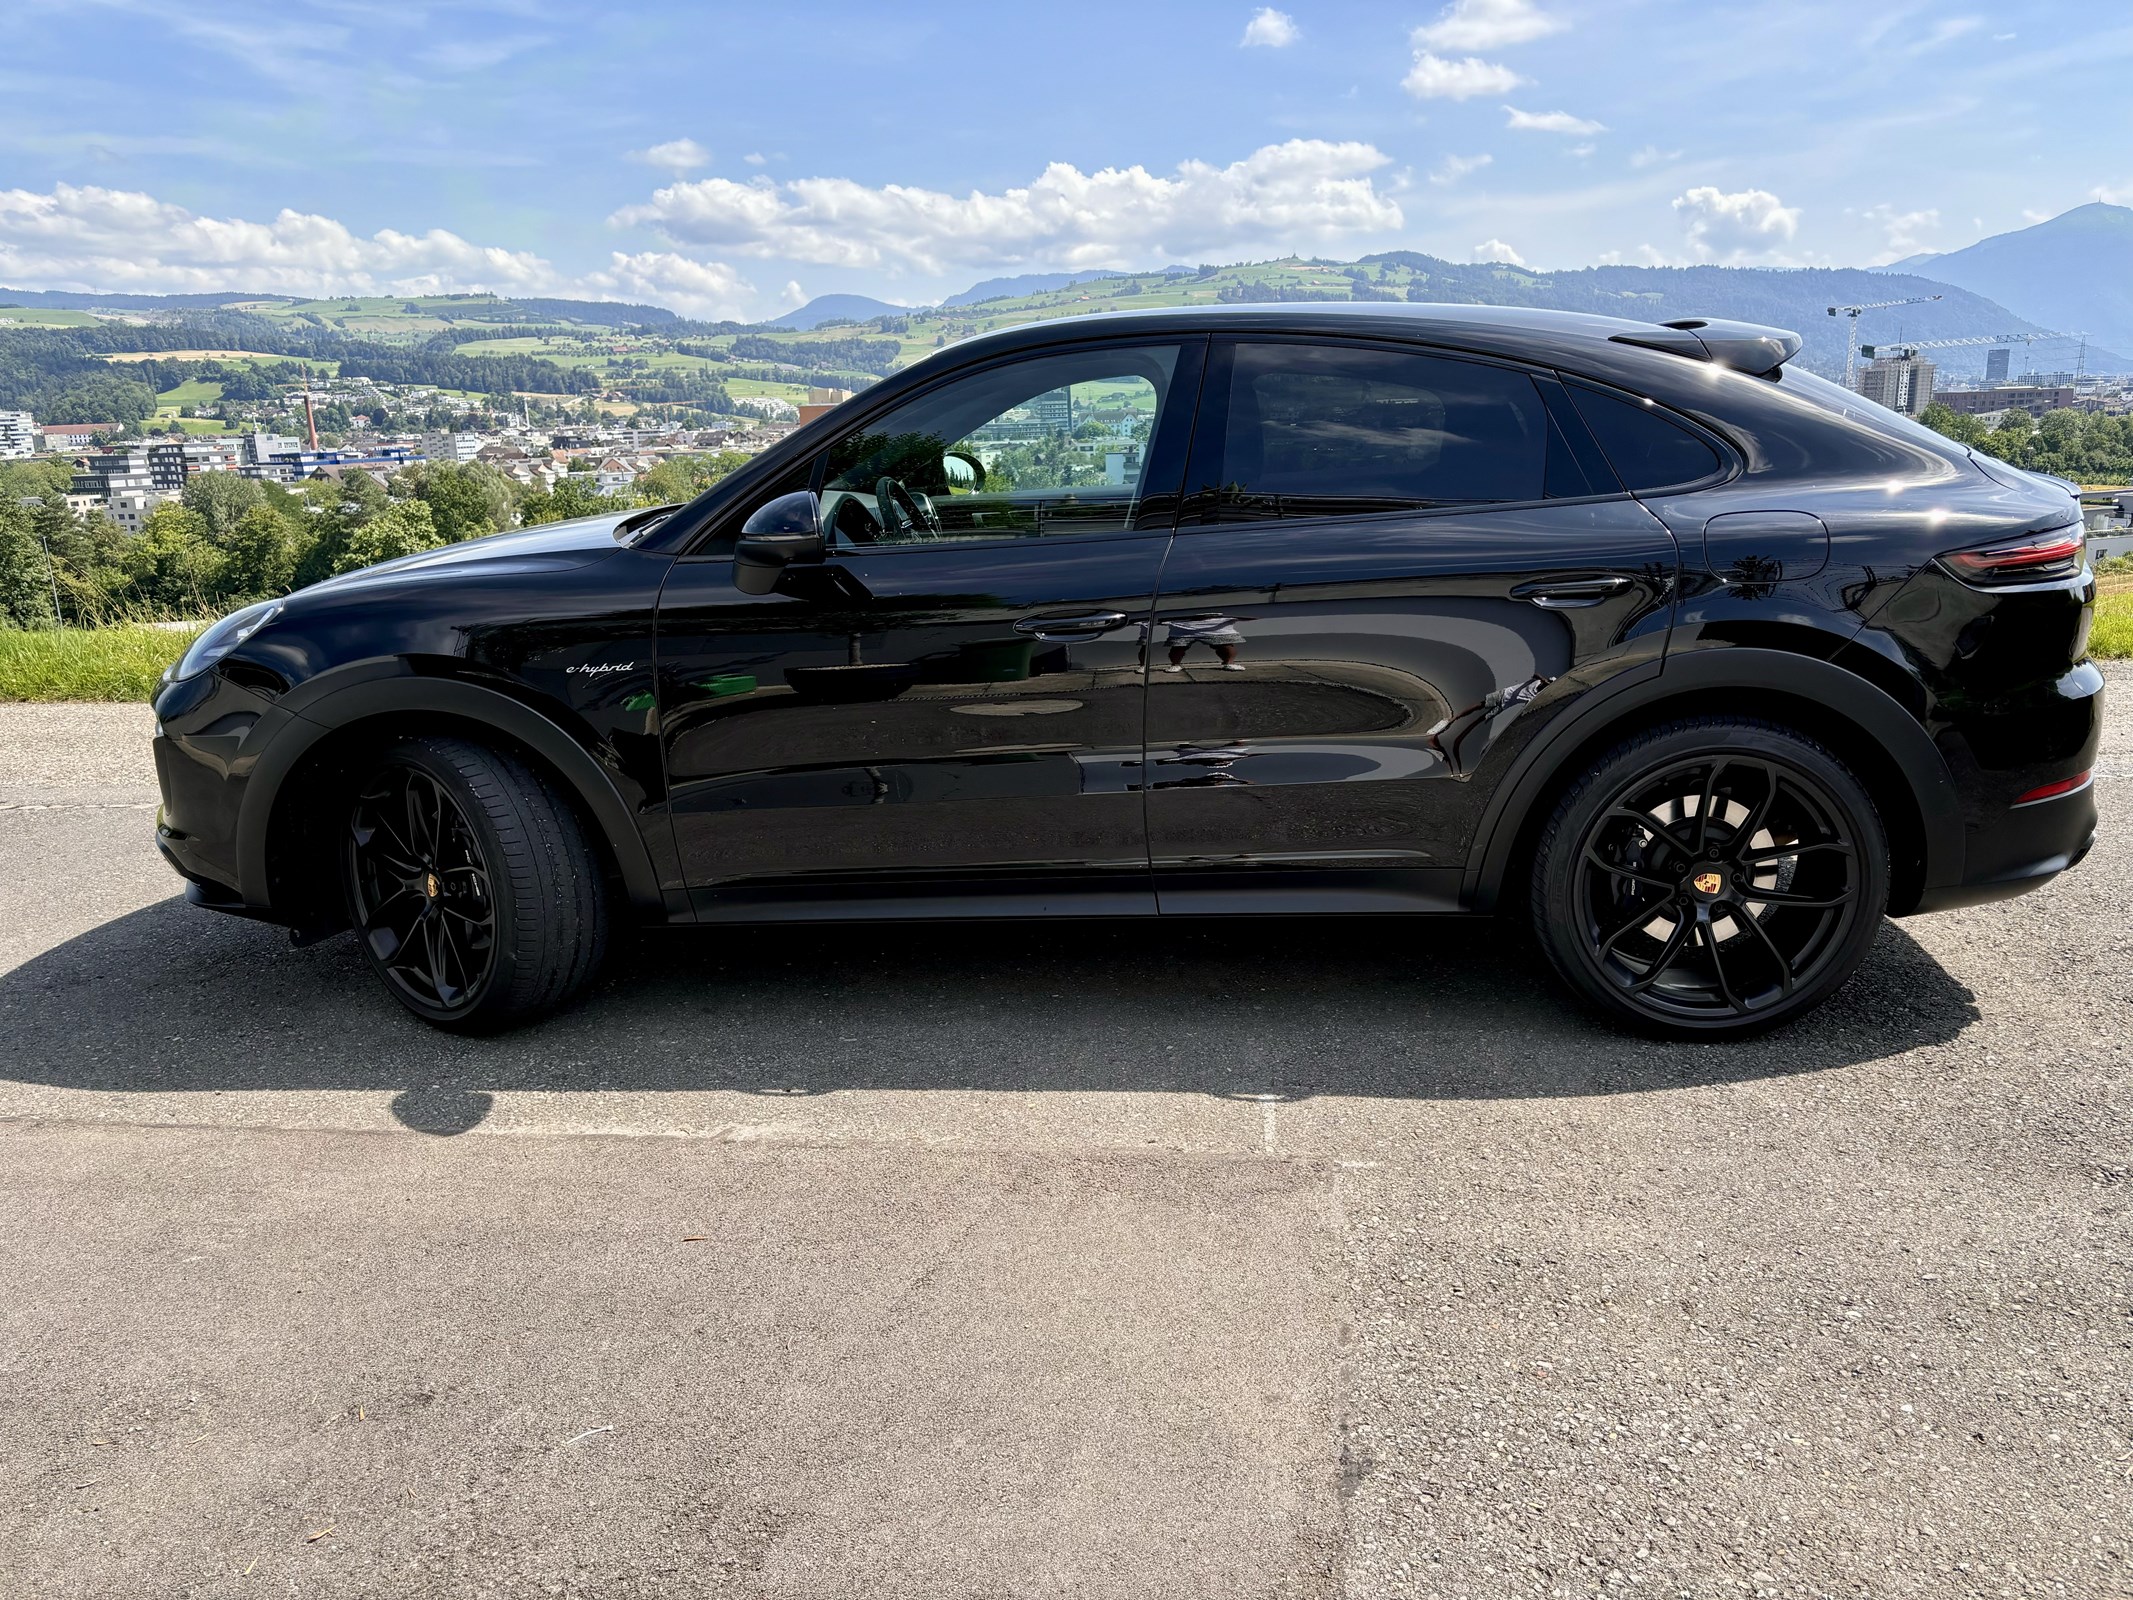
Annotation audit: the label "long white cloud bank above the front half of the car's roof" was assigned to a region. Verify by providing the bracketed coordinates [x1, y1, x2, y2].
[608, 139, 1401, 275]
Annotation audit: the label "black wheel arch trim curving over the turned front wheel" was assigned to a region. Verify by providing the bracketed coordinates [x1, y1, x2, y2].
[237, 670, 665, 928]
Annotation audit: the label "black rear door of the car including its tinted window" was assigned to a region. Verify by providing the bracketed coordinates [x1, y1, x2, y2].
[1148, 339, 1677, 911]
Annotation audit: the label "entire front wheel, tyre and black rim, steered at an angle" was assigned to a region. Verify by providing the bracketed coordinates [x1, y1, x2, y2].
[341, 736, 612, 1033]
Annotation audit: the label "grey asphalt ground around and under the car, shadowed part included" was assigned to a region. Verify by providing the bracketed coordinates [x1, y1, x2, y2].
[0, 686, 2133, 1600]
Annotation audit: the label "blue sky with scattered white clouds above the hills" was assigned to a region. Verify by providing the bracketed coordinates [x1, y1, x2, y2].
[12, 0, 2133, 316]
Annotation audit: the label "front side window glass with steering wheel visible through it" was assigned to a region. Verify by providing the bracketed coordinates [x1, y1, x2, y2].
[821, 346, 1177, 548]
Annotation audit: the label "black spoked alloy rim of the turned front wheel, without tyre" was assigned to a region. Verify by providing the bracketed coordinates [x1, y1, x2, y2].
[348, 762, 497, 1015]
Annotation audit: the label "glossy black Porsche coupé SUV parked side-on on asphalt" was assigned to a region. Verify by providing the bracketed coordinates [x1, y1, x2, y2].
[156, 305, 2103, 1037]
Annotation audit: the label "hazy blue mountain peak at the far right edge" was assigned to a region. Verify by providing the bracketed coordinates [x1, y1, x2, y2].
[1883, 201, 2133, 365]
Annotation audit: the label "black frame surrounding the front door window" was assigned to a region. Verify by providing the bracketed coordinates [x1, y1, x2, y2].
[676, 331, 1209, 561]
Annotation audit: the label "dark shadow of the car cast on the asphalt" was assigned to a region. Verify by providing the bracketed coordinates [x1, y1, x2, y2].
[0, 898, 1977, 1133]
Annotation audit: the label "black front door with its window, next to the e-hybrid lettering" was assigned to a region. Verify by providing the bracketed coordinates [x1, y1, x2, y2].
[659, 343, 1199, 917]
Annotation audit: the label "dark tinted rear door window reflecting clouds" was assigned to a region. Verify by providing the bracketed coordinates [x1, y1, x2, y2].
[1194, 343, 1552, 523]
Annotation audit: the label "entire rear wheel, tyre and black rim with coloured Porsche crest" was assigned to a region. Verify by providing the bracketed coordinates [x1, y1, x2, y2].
[1531, 717, 1888, 1039]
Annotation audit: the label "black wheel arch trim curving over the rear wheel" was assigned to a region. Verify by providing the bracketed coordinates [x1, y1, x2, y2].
[1463, 649, 1964, 915]
